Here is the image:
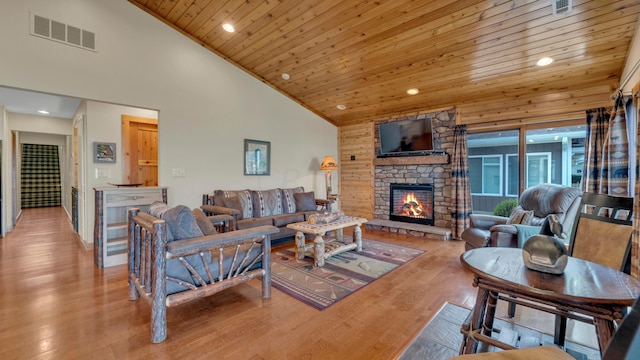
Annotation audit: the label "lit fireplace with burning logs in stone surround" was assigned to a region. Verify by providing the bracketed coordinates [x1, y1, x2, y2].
[389, 184, 433, 225]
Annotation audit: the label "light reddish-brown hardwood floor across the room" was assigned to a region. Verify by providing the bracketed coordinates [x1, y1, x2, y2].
[0, 208, 596, 359]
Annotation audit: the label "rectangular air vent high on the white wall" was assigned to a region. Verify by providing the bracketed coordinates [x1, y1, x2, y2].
[31, 15, 96, 51]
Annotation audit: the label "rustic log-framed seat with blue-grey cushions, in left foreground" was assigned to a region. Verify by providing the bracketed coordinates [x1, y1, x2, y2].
[128, 206, 278, 343]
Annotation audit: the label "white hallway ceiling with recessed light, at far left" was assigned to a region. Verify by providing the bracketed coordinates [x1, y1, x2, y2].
[0, 86, 81, 119]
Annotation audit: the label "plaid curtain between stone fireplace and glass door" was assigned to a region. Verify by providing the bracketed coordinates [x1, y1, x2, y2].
[451, 125, 472, 239]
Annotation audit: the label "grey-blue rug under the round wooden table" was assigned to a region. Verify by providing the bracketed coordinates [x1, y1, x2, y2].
[398, 303, 600, 360]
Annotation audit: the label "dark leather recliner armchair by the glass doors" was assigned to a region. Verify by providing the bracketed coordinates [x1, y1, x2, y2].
[461, 184, 582, 250]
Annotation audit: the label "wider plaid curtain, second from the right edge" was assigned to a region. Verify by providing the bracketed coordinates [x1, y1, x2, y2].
[598, 92, 629, 196]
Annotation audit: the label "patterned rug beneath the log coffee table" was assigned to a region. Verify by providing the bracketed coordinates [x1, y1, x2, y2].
[271, 235, 424, 310]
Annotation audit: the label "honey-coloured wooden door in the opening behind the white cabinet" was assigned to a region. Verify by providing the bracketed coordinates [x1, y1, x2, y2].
[122, 115, 158, 186]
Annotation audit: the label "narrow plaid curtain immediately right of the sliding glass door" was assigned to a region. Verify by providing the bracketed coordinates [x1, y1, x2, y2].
[582, 107, 609, 193]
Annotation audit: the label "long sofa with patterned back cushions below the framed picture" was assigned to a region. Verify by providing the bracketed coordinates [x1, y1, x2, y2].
[201, 186, 330, 240]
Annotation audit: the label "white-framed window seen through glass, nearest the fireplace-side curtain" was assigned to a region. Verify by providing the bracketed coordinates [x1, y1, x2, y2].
[469, 155, 503, 196]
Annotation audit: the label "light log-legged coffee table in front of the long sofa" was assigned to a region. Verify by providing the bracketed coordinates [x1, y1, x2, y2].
[287, 216, 367, 266]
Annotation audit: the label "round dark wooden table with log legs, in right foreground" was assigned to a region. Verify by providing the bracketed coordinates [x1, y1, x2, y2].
[460, 247, 640, 354]
